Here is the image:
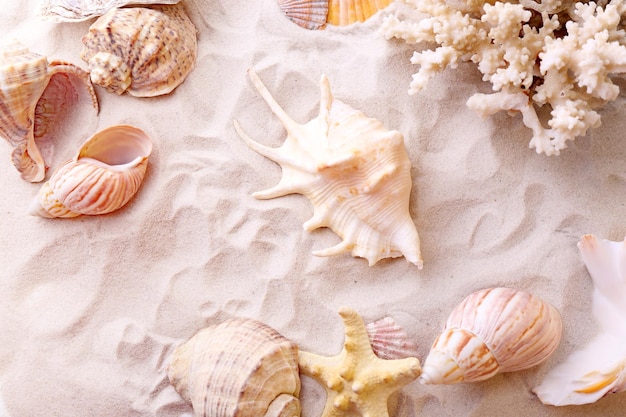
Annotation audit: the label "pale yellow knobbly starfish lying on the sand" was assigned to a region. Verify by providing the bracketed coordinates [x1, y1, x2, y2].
[298, 307, 421, 417]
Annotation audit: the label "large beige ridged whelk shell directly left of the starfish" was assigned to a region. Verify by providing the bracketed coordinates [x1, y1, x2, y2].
[168, 318, 300, 417]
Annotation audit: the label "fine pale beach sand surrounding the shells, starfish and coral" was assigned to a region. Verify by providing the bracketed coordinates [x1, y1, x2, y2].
[0, 0, 626, 417]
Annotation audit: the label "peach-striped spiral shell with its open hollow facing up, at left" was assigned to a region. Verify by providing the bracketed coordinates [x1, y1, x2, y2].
[30, 125, 152, 217]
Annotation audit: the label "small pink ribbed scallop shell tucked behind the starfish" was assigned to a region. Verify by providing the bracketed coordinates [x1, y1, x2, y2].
[365, 317, 419, 359]
